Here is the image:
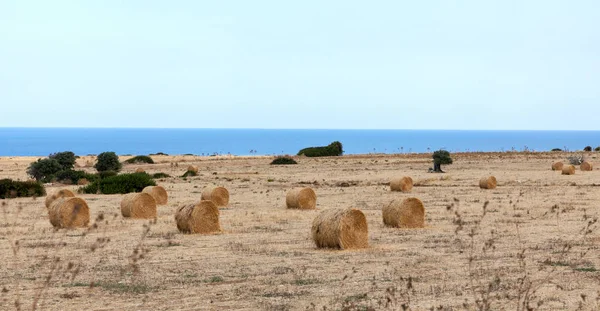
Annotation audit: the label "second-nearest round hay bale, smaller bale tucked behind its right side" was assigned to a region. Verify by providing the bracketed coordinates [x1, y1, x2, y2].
[175, 200, 221, 233]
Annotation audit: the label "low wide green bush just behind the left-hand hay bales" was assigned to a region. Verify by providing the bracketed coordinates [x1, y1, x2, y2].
[80, 173, 156, 194]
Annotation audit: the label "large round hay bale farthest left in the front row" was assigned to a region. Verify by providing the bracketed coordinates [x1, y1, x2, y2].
[48, 197, 90, 228]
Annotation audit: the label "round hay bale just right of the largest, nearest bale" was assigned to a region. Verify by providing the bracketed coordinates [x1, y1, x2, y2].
[382, 198, 425, 228]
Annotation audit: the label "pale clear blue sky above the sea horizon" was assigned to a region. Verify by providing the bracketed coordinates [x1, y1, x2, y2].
[0, 0, 600, 130]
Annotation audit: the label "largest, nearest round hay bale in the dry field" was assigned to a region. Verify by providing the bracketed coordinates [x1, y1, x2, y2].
[311, 208, 369, 249]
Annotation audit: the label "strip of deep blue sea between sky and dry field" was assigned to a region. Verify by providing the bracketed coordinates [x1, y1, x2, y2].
[0, 128, 600, 156]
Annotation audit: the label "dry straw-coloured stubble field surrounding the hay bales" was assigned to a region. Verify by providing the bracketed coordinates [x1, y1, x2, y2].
[0, 153, 600, 310]
